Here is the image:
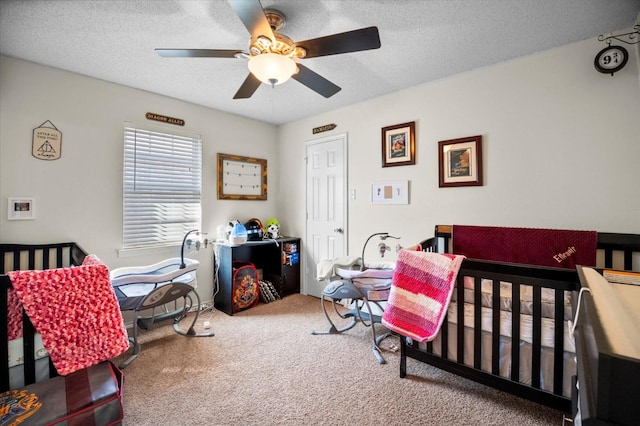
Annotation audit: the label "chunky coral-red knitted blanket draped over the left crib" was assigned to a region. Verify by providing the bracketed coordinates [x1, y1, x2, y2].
[8, 256, 129, 375]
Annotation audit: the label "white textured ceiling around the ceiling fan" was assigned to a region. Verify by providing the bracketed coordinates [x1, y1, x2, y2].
[0, 0, 640, 124]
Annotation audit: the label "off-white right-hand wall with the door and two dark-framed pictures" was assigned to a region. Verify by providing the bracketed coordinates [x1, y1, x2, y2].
[278, 35, 640, 292]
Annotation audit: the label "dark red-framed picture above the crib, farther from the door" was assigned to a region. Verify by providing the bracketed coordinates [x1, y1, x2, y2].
[438, 135, 482, 188]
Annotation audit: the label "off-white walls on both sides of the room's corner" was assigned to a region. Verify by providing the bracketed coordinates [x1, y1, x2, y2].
[0, 31, 640, 300]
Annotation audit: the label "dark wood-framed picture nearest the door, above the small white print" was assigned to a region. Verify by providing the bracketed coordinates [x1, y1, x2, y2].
[382, 121, 416, 167]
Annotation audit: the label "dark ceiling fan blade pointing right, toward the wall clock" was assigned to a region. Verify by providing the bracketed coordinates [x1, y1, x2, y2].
[296, 27, 380, 58]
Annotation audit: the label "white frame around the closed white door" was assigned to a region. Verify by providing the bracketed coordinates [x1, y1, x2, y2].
[301, 132, 349, 294]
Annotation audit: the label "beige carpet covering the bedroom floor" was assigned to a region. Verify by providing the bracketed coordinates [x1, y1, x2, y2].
[115, 295, 562, 426]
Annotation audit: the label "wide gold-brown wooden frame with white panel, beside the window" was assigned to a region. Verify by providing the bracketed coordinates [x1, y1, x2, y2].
[218, 153, 267, 200]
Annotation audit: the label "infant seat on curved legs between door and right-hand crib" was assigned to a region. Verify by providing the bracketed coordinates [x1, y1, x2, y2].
[311, 265, 394, 364]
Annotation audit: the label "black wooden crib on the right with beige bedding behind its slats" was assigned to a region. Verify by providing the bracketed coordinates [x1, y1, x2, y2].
[400, 226, 640, 413]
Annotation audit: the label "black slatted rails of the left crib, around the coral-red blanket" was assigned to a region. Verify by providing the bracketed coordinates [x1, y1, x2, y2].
[0, 242, 87, 392]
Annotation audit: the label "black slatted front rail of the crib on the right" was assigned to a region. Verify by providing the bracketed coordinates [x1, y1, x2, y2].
[400, 259, 579, 413]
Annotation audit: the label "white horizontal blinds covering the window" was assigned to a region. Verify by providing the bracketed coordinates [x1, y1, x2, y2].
[123, 125, 202, 249]
